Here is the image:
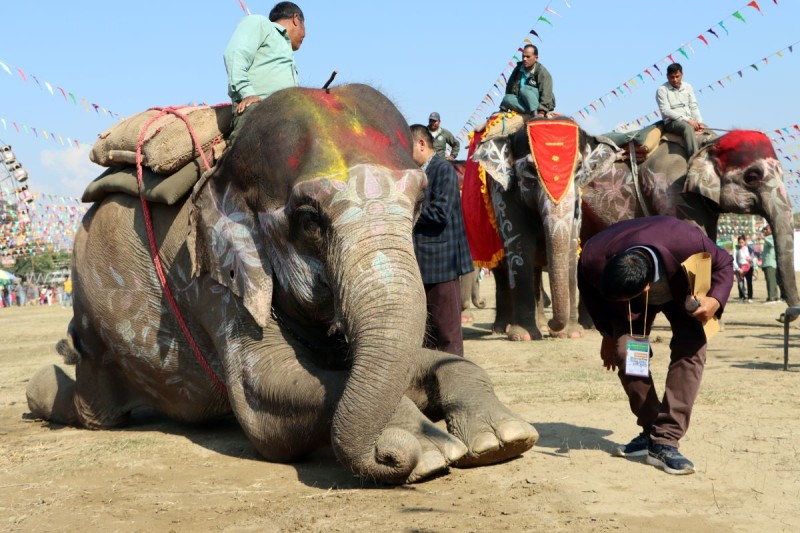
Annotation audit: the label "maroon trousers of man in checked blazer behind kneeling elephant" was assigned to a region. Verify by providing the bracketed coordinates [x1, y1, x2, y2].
[423, 278, 464, 357]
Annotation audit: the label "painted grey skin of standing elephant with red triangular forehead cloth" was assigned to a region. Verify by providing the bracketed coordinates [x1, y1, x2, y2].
[473, 119, 616, 341]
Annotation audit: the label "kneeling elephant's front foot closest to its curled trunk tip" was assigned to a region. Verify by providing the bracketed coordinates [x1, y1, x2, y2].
[376, 396, 467, 483]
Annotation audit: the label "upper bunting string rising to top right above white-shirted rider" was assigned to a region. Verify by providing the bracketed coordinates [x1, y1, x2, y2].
[571, 0, 778, 122]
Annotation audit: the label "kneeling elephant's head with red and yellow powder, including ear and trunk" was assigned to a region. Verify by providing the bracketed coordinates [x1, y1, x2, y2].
[190, 85, 426, 480]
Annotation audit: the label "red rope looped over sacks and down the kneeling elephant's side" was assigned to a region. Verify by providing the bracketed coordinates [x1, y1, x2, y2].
[136, 106, 228, 397]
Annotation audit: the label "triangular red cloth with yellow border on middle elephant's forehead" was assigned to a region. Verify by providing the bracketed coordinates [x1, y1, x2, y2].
[527, 120, 580, 203]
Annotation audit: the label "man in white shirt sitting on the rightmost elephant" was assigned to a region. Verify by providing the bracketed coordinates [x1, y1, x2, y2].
[656, 63, 706, 157]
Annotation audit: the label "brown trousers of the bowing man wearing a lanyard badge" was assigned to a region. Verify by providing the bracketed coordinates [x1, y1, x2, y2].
[614, 302, 706, 447]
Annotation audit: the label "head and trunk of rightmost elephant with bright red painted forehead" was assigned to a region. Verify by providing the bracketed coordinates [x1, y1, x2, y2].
[684, 130, 800, 306]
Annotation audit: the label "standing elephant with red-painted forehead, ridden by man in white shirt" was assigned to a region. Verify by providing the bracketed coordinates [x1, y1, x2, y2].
[581, 130, 800, 306]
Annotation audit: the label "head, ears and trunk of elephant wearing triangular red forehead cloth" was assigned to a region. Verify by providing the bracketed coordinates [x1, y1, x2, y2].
[473, 119, 617, 332]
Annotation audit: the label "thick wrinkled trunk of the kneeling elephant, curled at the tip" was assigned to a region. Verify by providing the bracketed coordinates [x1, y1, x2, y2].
[332, 228, 426, 483]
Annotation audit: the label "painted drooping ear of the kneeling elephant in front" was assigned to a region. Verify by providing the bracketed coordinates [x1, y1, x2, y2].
[188, 171, 272, 328]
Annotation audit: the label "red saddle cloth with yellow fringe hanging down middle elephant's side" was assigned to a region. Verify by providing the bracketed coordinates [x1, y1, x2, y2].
[461, 131, 503, 268]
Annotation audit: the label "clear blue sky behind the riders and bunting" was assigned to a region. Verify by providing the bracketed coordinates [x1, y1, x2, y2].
[0, 0, 800, 205]
